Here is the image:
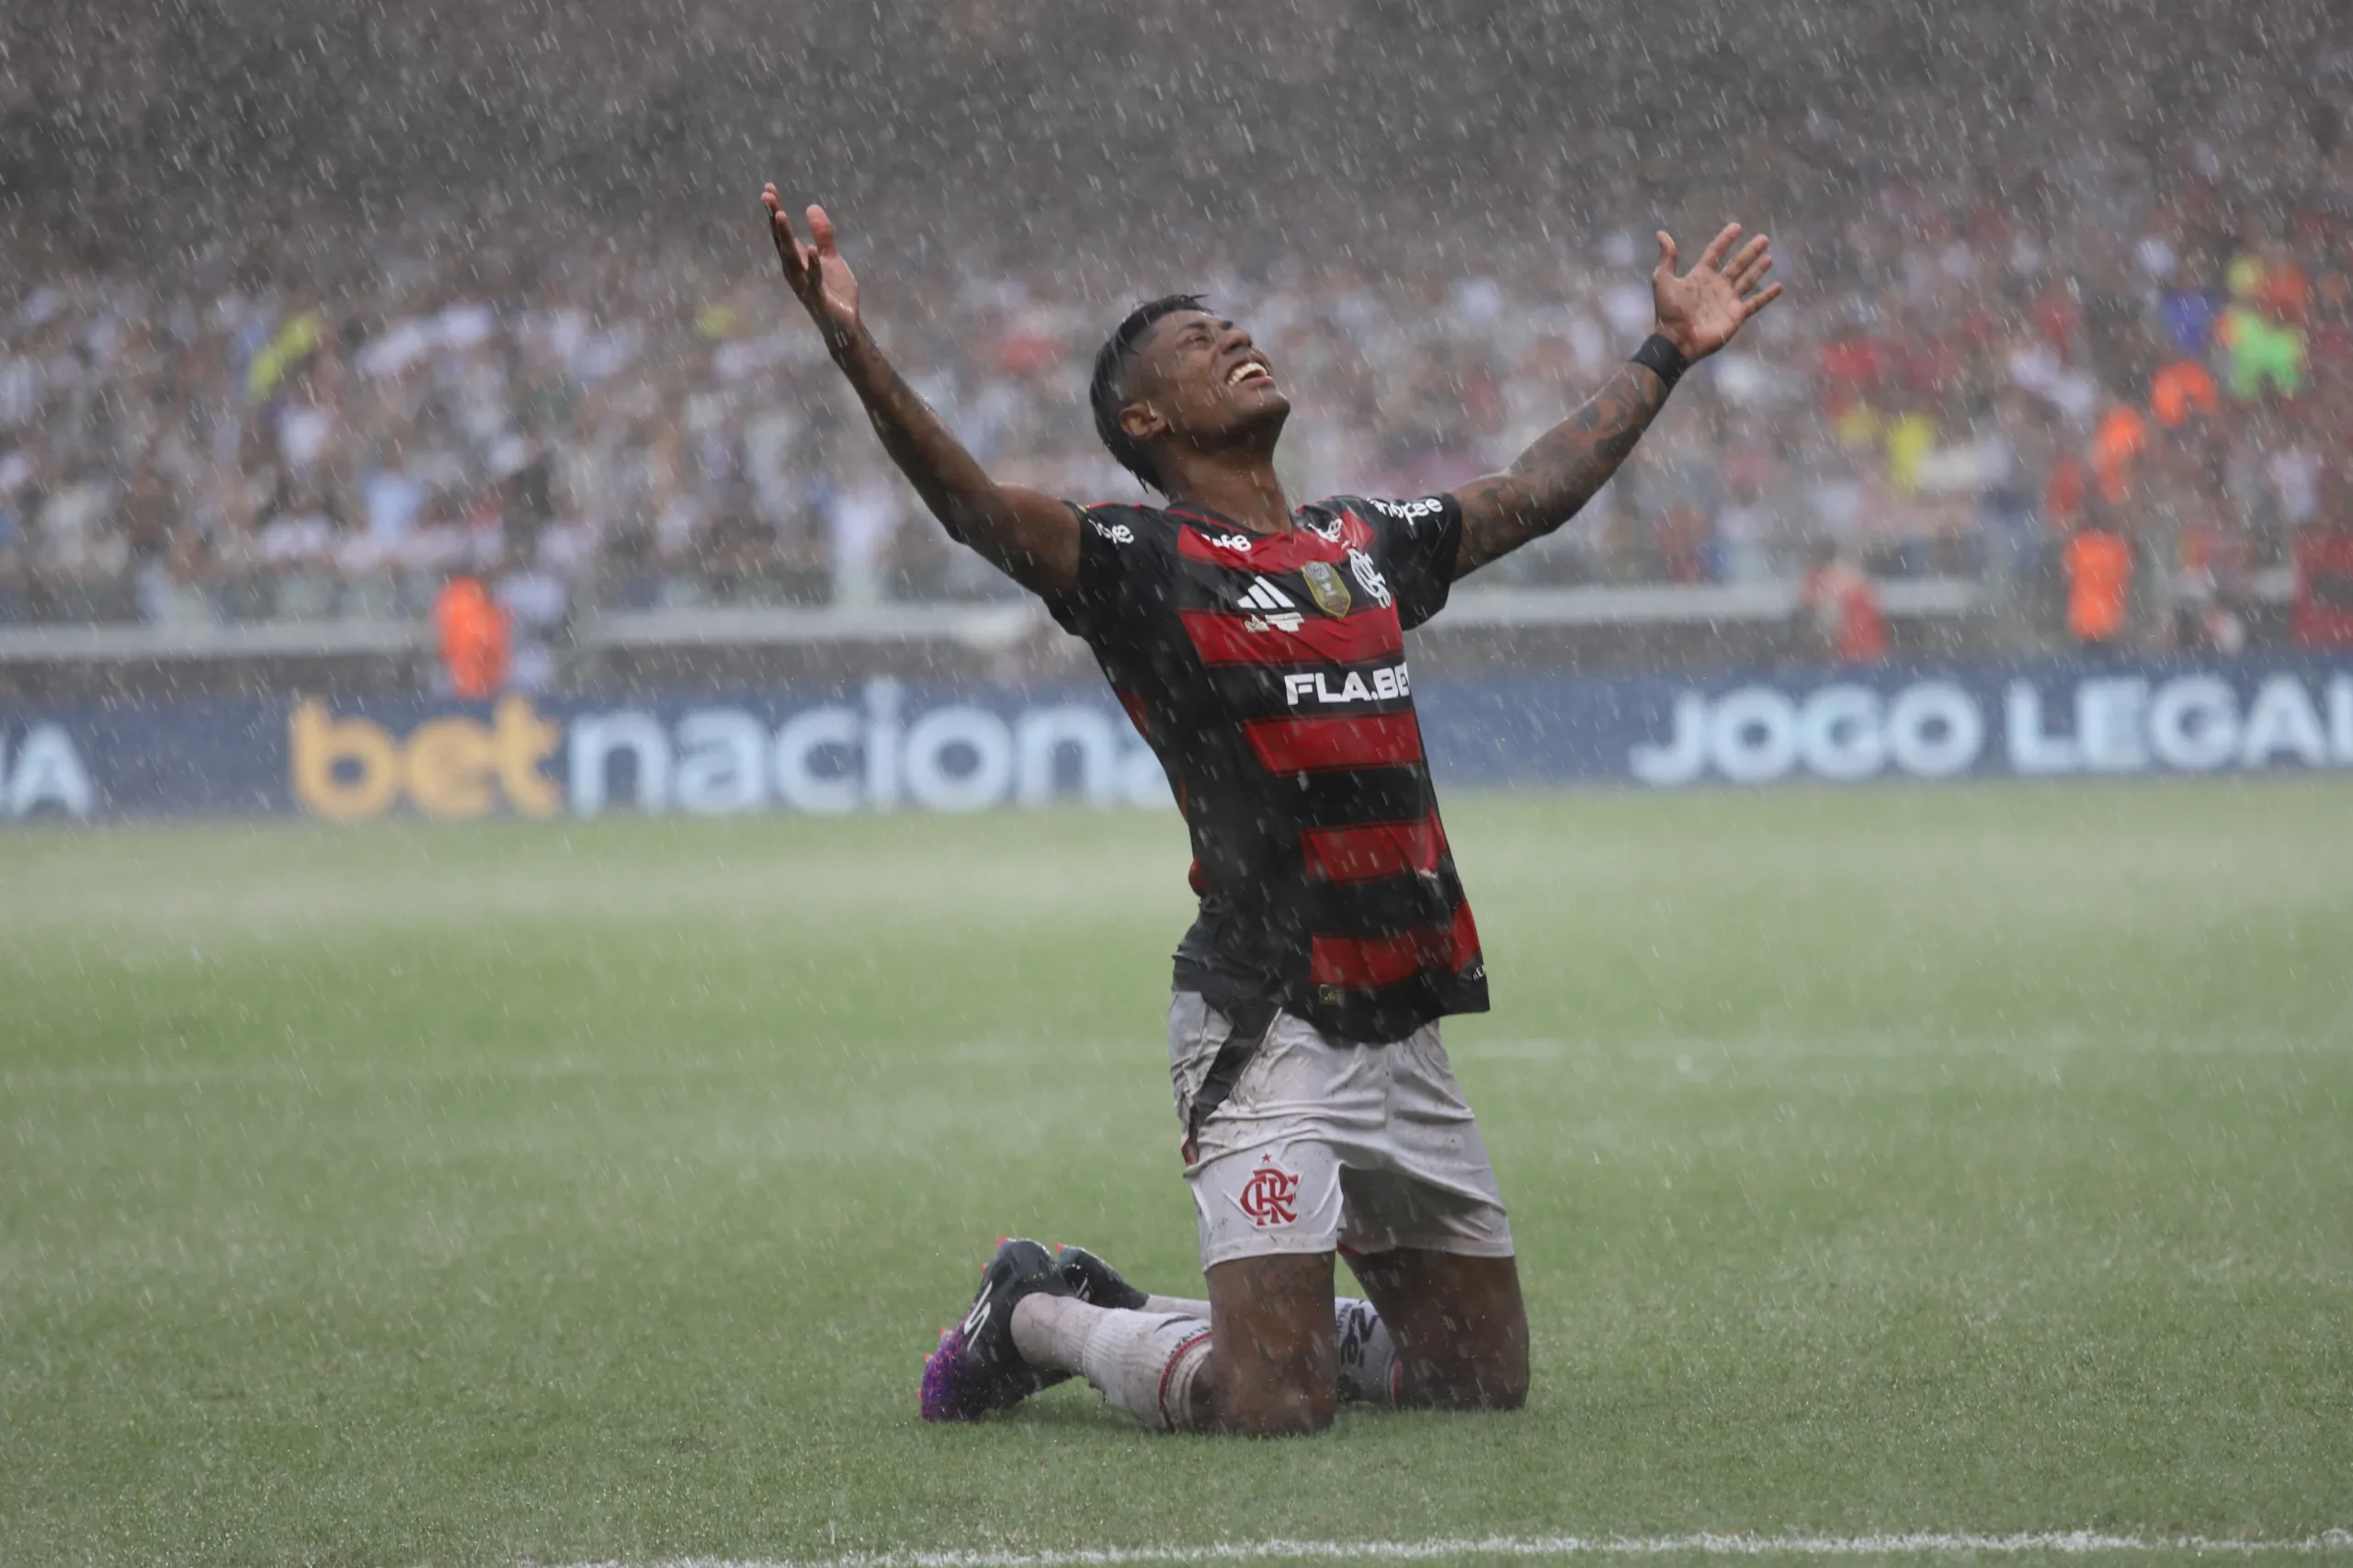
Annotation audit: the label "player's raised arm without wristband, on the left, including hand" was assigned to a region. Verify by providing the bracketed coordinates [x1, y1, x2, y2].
[760, 186, 1077, 596]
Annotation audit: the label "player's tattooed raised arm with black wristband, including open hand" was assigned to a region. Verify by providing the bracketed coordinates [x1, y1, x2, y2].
[1454, 223, 1781, 577]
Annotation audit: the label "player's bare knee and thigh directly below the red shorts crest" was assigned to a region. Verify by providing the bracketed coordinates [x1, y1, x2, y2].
[1195, 1253, 1339, 1437]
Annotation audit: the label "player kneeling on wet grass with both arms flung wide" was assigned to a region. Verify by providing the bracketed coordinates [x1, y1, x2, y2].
[762, 186, 1781, 1437]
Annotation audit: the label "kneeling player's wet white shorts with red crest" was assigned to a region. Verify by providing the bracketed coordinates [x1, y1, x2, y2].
[1169, 991, 1511, 1269]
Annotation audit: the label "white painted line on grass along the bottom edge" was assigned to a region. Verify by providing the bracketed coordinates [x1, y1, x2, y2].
[555, 1530, 2353, 1568]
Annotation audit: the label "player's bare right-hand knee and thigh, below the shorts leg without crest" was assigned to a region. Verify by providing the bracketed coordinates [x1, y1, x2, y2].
[1348, 1248, 1529, 1410]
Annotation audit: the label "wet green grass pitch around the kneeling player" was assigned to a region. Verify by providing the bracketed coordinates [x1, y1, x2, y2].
[0, 781, 2353, 1565]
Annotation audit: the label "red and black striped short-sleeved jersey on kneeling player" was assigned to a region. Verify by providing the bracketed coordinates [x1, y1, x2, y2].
[1047, 496, 1487, 1040]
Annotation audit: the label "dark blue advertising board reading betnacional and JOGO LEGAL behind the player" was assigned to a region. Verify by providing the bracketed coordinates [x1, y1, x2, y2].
[0, 657, 2353, 822]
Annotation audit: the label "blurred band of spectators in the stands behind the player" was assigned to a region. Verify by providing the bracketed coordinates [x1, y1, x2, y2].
[0, 112, 2353, 654]
